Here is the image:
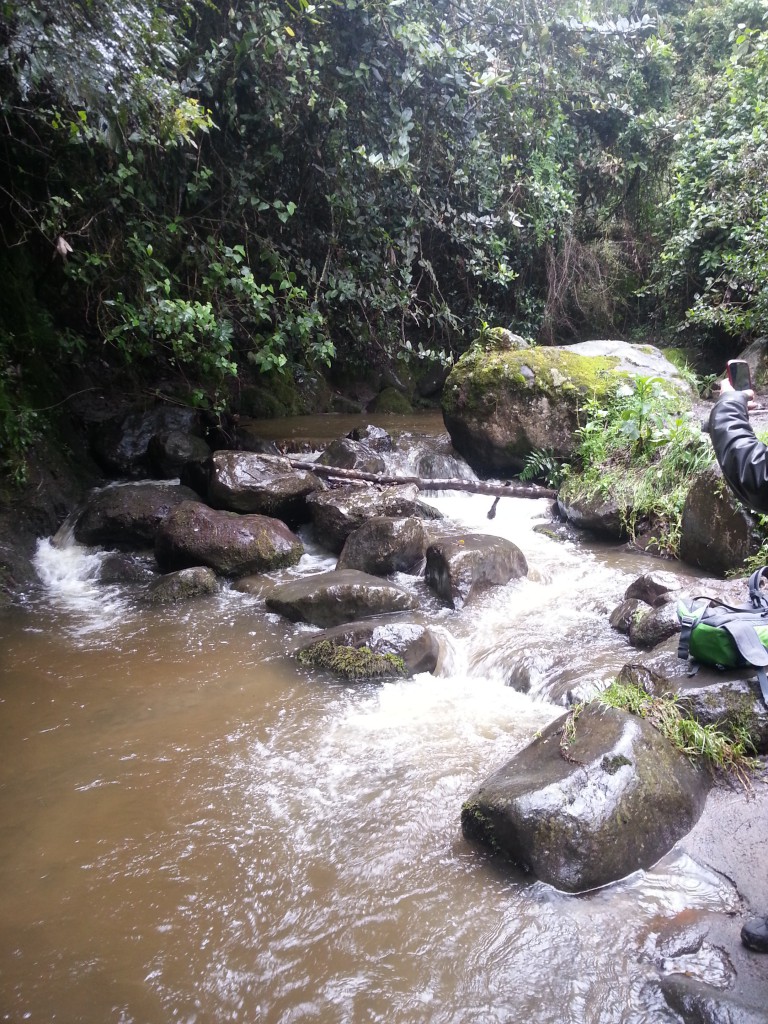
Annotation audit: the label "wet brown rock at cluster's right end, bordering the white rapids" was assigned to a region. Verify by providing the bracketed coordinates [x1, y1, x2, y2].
[425, 534, 528, 608]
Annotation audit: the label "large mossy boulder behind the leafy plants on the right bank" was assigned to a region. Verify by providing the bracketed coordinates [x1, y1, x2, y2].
[442, 341, 690, 475]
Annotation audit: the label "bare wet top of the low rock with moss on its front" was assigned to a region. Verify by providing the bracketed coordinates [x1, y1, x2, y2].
[299, 616, 440, 677]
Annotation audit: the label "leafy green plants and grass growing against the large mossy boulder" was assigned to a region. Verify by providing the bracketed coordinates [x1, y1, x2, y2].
[570, 378, 714, 556]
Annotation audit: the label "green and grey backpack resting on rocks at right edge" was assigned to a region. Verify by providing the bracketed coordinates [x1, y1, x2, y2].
[677, 566, 768, 705]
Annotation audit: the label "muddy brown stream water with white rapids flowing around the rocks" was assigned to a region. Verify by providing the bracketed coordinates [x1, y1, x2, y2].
[0, 417, 736, 1024]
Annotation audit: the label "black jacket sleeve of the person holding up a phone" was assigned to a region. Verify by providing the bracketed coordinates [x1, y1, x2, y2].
[710, 391, 768, 512]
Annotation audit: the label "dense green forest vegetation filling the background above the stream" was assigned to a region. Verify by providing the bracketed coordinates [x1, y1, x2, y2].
[0, 0, 768, 479]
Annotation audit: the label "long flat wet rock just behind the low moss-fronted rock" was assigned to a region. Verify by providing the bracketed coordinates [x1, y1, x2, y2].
[266, 569, 419, 629]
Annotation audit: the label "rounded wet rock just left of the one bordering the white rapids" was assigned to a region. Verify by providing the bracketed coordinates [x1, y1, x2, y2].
[336, 516, 427, 575]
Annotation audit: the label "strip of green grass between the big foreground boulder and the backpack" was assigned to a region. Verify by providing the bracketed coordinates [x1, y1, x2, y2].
[595, 680, 759, 787]
